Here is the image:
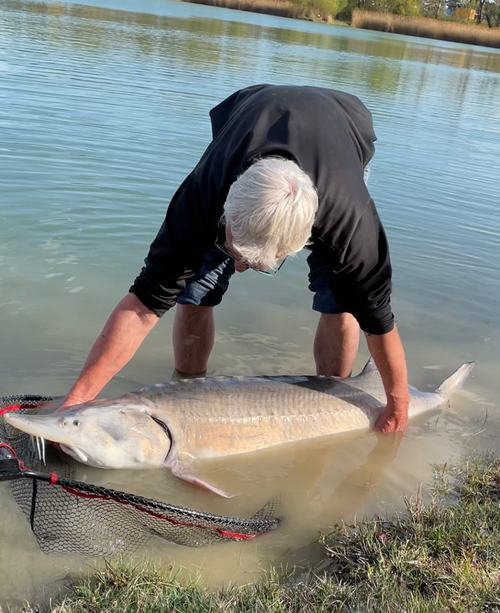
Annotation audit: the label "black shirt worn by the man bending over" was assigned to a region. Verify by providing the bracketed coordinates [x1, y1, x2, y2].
[130, 85, 394, 334]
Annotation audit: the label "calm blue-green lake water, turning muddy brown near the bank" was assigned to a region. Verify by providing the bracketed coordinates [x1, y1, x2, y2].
[0, 0, 500, 605]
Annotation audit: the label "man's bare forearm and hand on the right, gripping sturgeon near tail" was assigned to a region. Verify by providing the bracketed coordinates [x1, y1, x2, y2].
[366, 327, 410, 432]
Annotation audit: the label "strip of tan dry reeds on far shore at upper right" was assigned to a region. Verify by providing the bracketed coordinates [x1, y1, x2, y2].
[351, 9, 500, 48]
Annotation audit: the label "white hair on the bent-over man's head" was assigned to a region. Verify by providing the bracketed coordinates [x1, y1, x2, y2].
[223, 157, 318, 268]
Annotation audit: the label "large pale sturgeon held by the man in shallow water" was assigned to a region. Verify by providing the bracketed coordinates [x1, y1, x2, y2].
[4, 360, 474, 496]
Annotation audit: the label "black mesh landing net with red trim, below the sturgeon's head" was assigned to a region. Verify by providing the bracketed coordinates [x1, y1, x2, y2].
[0, 396, 280, 556]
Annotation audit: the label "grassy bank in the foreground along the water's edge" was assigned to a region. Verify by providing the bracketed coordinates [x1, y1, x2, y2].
[19, 458, 500, 613]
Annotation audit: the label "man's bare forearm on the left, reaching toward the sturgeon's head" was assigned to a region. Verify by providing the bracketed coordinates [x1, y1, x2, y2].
[62, 294, 159, 407]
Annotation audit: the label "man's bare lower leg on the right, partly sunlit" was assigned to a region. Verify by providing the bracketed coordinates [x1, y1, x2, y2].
[314, 313, 359, 377]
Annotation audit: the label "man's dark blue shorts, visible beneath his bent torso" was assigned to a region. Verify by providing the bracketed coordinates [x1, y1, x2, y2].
[177, 247, 343, 314]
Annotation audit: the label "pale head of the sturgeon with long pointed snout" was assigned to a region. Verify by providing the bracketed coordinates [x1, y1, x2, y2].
[3, 395, 171, 468]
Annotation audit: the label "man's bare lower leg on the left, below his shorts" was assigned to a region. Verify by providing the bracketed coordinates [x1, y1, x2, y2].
[173, 304, 215, 375]
